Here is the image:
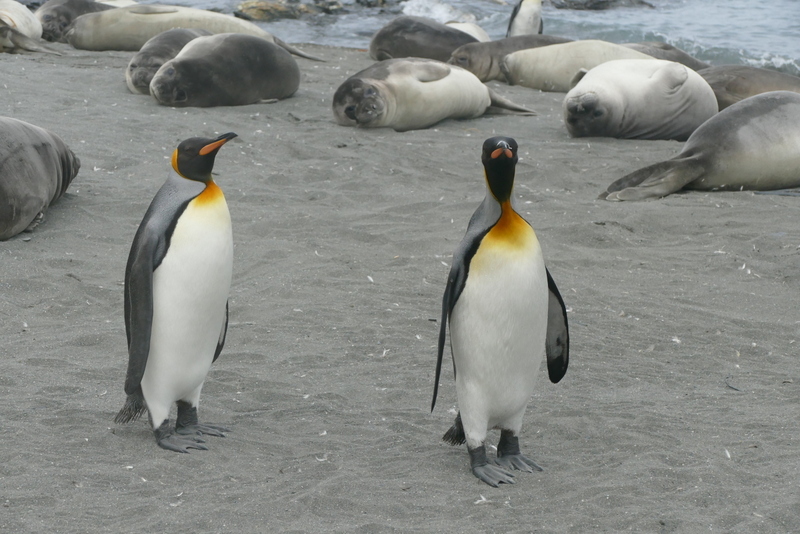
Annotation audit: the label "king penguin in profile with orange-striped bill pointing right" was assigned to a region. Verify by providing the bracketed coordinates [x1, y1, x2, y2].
[114, 133, 236, 452]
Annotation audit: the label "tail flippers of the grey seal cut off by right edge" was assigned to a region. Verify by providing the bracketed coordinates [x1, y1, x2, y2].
[597, 157, 706, 204]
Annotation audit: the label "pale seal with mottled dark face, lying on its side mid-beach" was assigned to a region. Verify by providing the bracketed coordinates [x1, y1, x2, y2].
[333, 58, 534, 132]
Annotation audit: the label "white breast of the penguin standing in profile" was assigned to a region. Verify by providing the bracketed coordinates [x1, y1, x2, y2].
[142, 183, 233, 404]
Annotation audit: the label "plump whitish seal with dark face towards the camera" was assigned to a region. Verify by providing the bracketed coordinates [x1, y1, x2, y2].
[563, 59, 718, 141]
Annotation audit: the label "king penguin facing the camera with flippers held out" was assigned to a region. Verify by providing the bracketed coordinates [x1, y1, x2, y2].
[431, 137, 569, 487]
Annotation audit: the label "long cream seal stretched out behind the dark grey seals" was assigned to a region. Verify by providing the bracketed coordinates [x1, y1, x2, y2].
[66, 4, 322, 61]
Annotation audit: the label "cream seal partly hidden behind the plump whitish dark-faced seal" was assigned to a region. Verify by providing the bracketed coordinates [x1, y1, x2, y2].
[500, 40, 653, 93]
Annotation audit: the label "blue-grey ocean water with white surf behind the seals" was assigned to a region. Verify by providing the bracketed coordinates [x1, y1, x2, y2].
[162, 0, 800, 75]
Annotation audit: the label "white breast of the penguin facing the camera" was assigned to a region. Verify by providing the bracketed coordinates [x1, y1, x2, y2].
[450, 218, 548, 426]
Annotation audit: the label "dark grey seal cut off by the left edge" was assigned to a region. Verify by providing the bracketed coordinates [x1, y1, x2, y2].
[0, 117, 81, 241]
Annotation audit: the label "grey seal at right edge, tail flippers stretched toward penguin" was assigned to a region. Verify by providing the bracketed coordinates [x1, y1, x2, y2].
[600, 91, 800, 200]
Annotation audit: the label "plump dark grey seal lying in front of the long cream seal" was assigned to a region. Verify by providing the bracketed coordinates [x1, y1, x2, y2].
[150, 33, 300, 107]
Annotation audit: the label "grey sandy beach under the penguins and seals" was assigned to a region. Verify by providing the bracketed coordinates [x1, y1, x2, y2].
[0, 45, 800, 533]
